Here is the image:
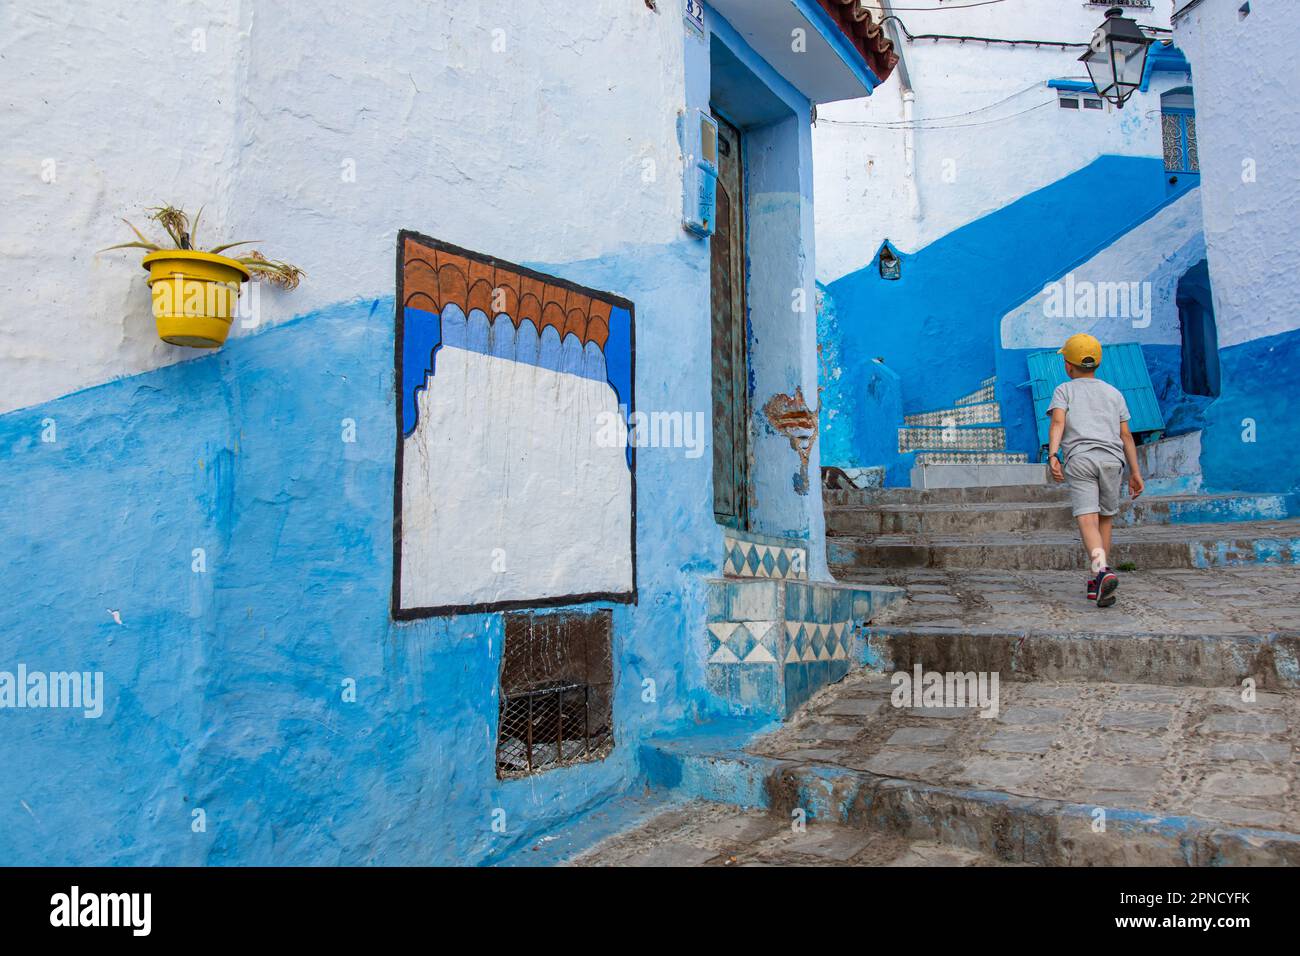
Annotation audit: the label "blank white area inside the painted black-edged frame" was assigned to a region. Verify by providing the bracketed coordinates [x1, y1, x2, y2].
[402, 332, 633, 607]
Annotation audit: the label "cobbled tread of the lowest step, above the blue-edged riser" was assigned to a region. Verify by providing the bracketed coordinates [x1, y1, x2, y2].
[750, 671, 1300, 832]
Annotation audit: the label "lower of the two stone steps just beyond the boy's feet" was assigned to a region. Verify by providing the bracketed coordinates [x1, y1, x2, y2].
[827, 519, 1300, 571]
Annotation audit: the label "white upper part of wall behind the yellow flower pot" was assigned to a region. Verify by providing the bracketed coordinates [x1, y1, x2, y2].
[0, 0, 685, 411]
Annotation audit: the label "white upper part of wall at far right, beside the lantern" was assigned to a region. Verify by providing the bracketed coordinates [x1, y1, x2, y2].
[1174, 0, 1300, 346]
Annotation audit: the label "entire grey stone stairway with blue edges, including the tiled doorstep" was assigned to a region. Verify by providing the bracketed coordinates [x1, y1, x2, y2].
[548, 486, 1300, 866]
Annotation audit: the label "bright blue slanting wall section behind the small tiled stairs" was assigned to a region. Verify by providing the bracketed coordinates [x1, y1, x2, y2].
[823, 156, 1195, 483]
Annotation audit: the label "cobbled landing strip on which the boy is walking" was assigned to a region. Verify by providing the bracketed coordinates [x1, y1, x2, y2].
[841, 566, 1300, 636]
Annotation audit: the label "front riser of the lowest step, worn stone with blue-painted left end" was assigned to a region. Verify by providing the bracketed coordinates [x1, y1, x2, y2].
[640, 745, 1300, 866]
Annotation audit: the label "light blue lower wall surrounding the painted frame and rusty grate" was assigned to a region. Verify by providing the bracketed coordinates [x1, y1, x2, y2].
[0, 264, 759, 864]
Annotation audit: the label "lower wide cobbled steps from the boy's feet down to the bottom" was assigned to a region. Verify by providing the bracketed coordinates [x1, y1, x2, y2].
[624, 561, 1300, 866]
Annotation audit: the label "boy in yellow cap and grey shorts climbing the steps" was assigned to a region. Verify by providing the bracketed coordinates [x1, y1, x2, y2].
[1048, 334, 1145, 607]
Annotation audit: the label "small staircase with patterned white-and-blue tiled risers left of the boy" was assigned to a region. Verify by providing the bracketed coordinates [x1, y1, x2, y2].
[898, 376, 1041, 488]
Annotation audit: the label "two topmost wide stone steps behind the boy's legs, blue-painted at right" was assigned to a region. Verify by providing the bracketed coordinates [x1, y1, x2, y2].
[824, 481, 1300, 580]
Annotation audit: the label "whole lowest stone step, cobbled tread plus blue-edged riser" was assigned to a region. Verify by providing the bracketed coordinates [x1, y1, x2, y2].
[640, 671, 1300, 866]
